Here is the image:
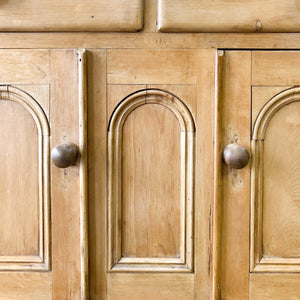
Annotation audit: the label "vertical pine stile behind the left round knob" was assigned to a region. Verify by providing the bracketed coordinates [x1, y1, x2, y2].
[50, 50, 81, 300]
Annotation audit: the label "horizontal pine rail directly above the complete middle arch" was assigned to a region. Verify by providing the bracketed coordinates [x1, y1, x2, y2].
[107, 49, 196, 84]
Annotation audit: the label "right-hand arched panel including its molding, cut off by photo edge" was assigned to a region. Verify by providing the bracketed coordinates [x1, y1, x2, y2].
[251, 87, 300, 272]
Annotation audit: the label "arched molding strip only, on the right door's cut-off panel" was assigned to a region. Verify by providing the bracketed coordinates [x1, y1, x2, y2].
[250, 87, 300, 273]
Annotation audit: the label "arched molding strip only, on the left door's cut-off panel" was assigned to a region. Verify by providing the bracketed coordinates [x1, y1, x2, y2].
[0, 85, 50, 271]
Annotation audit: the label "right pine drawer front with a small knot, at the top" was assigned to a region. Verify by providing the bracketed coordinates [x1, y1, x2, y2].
[158, 0, 300, 32]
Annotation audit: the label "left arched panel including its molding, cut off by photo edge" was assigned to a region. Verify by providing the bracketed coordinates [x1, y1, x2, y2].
[0, 85, 50, 271]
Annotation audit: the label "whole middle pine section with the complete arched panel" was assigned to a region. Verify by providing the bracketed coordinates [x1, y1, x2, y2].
[88, 49, 215, 300]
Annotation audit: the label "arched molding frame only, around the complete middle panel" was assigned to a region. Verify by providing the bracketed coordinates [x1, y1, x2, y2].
[108, 89, 195, 272]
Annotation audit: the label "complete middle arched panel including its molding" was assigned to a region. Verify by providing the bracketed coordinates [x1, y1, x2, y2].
[108, 89, 194, 272]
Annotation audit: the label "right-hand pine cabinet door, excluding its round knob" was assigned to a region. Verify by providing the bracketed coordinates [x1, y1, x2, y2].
[219, 51, 300, 300]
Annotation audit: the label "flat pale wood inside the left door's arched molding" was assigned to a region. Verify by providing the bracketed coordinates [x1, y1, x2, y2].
[0, 100, 40, 256]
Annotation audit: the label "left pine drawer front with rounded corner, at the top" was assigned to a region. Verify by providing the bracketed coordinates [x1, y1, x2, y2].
[0, 0, 143, 31]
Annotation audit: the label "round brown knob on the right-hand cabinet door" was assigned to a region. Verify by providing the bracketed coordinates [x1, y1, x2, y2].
[223, 144, 250, 169]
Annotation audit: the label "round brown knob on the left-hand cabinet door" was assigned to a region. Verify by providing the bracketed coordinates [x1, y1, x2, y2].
[51, 143, 79, 168]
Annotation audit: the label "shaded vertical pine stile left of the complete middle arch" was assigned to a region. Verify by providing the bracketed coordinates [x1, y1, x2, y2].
[87, 49, 107, 300]
